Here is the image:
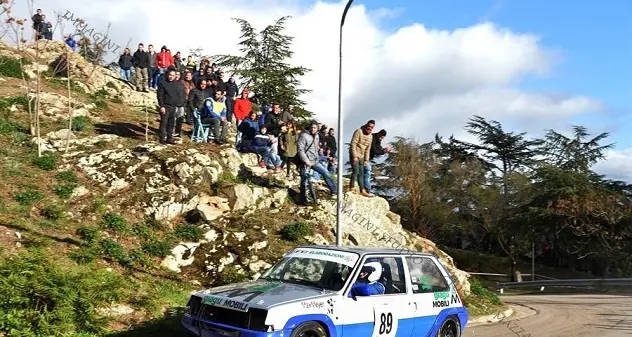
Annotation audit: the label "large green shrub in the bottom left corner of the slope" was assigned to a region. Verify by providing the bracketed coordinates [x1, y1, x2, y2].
[0, 251, 125, 337]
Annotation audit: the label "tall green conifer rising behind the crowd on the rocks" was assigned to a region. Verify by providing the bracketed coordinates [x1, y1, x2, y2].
[212, 16, 313, 118]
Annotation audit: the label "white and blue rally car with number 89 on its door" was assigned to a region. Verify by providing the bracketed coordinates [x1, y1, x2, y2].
[182, 246, 468, 337]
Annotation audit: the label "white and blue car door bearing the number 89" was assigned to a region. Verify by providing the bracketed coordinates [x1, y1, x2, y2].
[340, 255, 415, 337]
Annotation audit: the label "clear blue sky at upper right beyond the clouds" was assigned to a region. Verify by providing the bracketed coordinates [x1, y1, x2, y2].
[354, 0, 632, 148]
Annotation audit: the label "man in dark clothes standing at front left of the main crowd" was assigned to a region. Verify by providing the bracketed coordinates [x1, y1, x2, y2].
[157, 69, 184, 144]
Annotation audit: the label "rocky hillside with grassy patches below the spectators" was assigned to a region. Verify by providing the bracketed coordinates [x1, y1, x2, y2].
[0, 42, 491, 329]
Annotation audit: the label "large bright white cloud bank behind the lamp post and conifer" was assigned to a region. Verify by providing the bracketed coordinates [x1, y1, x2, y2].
[8, 0, 632, 181]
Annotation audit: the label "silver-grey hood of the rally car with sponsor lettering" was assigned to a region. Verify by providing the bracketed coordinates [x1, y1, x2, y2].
[195, 281, 335, 311]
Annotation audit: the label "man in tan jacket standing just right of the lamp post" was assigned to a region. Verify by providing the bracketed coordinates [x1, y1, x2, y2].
[349, 120, 375, 197]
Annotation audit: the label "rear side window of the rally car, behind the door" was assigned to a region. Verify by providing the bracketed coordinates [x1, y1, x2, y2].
[406, 256, 450, 294]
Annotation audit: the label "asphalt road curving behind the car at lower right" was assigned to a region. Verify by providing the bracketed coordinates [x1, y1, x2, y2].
[463, 294, 632, 337]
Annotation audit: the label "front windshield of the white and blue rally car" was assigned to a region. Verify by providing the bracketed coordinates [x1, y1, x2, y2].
[260, 257, 351, 291]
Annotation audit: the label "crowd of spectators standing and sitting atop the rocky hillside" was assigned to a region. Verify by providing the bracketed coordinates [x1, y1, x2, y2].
[56, 37, 390, 205]
